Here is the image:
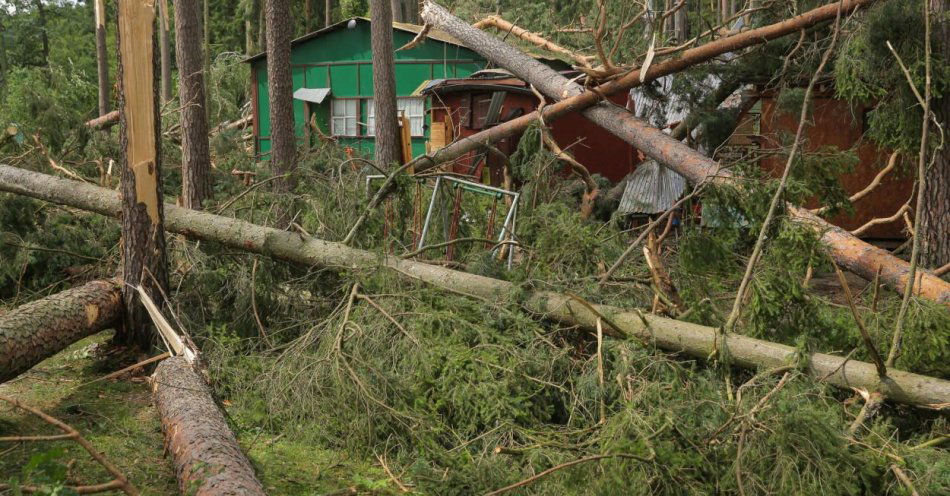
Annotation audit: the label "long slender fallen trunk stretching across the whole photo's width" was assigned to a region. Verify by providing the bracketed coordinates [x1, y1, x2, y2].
[0, 165, 950, 406]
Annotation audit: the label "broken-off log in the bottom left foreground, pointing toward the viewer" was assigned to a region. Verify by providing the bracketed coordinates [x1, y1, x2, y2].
[152, 356, 264, 496]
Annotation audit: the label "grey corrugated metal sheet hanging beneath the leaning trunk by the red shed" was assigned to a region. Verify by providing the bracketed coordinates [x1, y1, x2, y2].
[617, 160, 686, 214]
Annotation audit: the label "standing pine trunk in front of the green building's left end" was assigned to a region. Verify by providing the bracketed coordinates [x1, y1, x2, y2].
[266, 0, 296, 192]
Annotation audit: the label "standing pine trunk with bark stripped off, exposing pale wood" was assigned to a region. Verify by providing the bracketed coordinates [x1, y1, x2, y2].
[116, 0, 168, 349]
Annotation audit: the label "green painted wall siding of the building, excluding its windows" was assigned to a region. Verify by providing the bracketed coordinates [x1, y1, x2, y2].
[252, 19, 485, 159]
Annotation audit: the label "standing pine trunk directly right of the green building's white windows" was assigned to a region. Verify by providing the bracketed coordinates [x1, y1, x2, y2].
[370, 0, 400, 169]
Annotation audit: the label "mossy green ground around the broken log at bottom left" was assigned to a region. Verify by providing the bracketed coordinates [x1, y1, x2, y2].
[0, 333, 397, 495]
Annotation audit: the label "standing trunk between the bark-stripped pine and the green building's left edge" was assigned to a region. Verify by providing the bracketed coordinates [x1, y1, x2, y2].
[175, 0, 211, 210]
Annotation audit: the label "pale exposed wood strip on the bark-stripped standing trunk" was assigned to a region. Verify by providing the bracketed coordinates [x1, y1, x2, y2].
[118, 0, 158, 225]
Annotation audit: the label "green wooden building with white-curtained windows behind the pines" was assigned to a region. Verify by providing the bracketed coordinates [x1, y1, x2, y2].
[247, 17, 485, 157]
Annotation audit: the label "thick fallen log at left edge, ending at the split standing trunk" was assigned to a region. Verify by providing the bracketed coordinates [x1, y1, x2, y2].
[0, 281, 122, 383]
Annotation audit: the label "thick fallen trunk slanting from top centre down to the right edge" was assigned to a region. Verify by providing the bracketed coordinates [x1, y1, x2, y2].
[422, 0, 950, 305]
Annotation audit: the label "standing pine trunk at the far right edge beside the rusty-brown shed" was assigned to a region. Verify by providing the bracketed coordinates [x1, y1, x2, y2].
[917, 0, 950, 268]
